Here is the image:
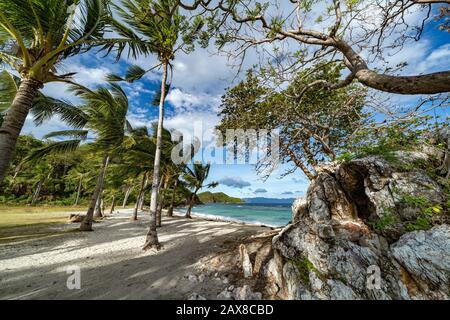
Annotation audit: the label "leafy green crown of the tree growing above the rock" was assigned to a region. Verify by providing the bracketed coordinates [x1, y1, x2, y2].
[218, 61, 368, 177]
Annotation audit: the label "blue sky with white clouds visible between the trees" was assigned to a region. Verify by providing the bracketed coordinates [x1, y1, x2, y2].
[19, 3, 450, 198]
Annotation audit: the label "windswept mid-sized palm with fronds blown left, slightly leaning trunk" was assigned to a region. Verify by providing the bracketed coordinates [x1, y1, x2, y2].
[29, 84, 130, 231]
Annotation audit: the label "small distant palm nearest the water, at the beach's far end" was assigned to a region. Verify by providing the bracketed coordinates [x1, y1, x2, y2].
[183, 162, 219, 219]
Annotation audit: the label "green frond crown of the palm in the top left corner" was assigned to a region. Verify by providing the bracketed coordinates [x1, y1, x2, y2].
[0, 0, 110, 83]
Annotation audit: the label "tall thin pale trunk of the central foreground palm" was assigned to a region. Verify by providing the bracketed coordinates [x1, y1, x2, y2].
[143, 61, 168, 250]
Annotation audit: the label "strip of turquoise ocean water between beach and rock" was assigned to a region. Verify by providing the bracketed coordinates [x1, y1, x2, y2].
[186, 203, 292, 227]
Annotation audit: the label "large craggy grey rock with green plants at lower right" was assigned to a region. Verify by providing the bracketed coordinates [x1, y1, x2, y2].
[260, 152, 450, 299]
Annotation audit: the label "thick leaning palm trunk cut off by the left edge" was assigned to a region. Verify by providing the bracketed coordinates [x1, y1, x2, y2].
[0, 79, 42, 183]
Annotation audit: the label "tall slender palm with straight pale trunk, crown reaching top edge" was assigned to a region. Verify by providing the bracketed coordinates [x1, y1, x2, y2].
[105, 0, 202, 250]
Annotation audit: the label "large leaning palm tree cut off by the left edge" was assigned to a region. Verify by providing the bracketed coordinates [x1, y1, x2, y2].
[0, 0, 114, 182]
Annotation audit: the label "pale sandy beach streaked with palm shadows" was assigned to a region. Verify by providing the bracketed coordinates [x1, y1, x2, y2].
[0, 209, 270, 299]
